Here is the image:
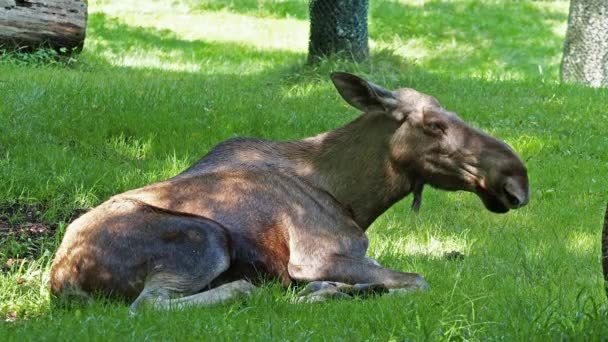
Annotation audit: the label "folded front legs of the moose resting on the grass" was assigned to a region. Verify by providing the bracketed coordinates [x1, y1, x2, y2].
[289, 255, 429, 301]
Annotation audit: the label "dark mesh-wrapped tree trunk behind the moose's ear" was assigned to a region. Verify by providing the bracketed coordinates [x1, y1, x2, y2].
[308, 0, 369, 63]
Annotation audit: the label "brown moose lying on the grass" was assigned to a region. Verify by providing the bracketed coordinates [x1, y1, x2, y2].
[50, 72, 530, 311]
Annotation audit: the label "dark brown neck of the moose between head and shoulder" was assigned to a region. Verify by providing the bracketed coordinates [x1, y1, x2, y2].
[297, 114, 412, 230]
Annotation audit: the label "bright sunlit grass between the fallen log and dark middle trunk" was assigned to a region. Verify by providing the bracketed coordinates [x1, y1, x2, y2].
[86, 1, 308, 73]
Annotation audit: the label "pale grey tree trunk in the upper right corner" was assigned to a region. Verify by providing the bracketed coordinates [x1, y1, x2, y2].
[561, 0, 608, 87]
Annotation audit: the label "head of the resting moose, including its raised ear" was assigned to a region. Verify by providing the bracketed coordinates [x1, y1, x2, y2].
[332, 73, 529, 213]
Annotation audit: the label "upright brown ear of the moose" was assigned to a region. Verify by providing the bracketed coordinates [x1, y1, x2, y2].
[331, 72, 398, 114]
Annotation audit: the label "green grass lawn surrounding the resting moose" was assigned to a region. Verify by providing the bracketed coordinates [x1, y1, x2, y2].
[0, 0, 608, 341]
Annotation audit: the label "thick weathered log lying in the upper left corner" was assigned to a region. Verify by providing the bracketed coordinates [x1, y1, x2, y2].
[0, 0, 87, 51]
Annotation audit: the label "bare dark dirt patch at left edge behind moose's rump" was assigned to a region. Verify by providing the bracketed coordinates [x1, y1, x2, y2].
[0, 202, 87, 262]
